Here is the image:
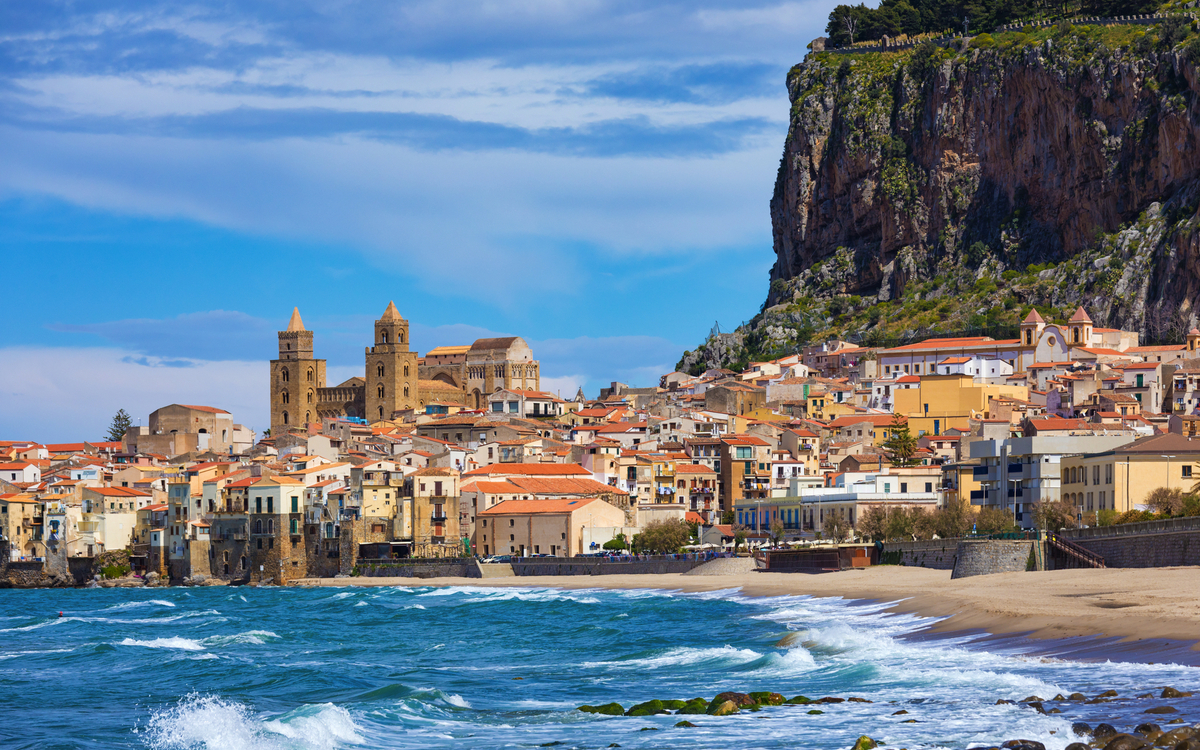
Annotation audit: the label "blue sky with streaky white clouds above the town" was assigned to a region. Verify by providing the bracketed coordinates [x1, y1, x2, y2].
[0, 0, 834, 442]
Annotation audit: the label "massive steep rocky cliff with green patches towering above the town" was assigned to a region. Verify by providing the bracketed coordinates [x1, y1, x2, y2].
[680, 23, 1200, 371]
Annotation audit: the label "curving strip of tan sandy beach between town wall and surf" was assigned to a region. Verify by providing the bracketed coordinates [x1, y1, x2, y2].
[295, 565, 1200, 650]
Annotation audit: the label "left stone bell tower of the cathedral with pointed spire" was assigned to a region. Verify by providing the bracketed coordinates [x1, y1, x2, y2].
[271, 307, 325, 434]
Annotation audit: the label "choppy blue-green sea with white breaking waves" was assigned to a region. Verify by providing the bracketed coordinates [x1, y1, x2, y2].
[0, 587, 1200, 750]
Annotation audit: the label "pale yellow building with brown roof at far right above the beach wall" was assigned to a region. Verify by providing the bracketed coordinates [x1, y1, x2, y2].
[1061, 433, 1200, 512]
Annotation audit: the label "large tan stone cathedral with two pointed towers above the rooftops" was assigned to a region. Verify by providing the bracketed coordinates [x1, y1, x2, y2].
[271, 302, 541, 434]
